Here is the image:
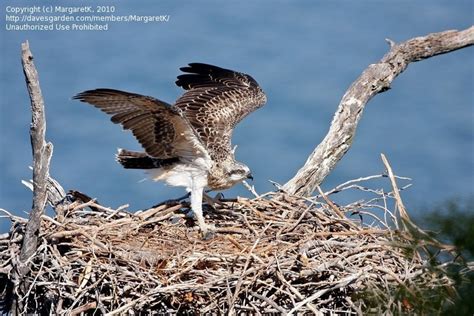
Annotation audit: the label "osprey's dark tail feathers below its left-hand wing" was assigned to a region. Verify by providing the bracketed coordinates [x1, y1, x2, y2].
[115, 148, 179, 169]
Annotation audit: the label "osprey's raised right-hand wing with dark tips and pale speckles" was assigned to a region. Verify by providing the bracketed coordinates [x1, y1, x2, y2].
[175, 63, 266, 160]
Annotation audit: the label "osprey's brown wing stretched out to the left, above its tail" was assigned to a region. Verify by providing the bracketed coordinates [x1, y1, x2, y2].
[74, 89, 207, 159]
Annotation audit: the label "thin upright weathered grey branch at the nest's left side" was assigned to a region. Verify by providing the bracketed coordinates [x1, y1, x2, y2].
[18, 42, 53, 280]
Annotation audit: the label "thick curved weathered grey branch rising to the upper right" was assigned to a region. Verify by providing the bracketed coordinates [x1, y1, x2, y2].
[283, 27, 474, 196]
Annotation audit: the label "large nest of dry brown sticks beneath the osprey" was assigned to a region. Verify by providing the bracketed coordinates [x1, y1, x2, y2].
[0, 179, 458, 315]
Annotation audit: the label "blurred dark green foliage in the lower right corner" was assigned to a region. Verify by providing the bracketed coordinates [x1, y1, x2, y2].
[358, 198, 474, 316]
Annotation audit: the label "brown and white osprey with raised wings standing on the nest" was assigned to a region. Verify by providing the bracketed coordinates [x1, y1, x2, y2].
[74, 63, 266, 238]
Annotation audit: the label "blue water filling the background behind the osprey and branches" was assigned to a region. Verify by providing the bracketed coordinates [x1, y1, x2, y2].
[0, 0, 474, 231]
